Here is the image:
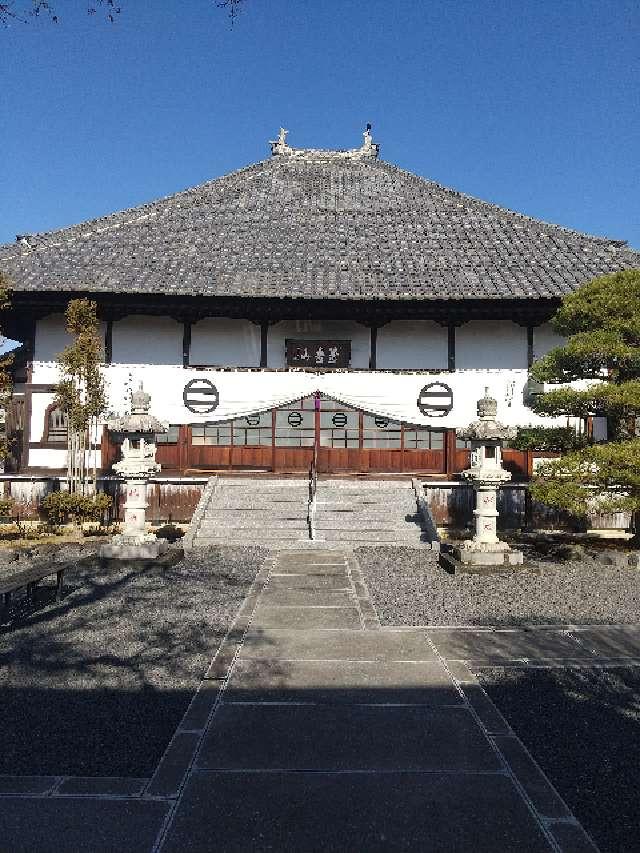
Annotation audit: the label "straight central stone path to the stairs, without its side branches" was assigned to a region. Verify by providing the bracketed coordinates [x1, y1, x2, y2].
[159, 551, 595, 853]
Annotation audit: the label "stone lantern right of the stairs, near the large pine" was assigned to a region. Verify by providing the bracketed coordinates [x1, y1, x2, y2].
[453, 388, 523, 567]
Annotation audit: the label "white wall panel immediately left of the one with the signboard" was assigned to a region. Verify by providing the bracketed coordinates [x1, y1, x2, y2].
[189, 317, 260, 367]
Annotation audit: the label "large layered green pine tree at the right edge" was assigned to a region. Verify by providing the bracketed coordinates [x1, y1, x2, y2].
[530, 270, 640, 543]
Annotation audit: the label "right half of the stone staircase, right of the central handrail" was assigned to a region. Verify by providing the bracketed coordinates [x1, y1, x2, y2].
[310, 480, 429, 547]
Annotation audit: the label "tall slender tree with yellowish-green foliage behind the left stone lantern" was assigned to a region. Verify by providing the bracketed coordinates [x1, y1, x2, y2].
[56, 299, 106, 494]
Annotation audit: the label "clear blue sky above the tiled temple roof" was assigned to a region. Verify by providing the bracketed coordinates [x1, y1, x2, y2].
[0, 0, 640, 248]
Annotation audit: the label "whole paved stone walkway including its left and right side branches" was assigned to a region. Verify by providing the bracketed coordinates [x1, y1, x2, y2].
[0, 550, 640, 853]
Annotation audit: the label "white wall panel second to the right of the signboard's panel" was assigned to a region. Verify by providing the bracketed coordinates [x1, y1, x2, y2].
[456, 320, 527, 370]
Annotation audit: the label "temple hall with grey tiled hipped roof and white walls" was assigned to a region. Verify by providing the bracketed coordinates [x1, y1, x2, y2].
[0, 128, 640, 477]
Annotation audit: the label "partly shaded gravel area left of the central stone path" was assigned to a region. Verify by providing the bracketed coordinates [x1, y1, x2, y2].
[0, 547, 266, 777]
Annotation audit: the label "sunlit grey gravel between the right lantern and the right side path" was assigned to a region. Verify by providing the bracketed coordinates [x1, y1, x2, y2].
[356, 547, 640, 625]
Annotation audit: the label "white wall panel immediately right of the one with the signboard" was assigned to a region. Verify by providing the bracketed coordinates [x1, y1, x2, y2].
[376, 320, 449, 370]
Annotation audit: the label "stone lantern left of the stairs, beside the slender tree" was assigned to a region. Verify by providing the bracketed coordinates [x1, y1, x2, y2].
[100, 382, 169, 560]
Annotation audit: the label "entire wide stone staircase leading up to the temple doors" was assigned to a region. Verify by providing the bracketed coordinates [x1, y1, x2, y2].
[183, 477, 430, 550]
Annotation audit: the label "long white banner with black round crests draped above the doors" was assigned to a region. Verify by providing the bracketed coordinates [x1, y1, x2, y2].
[96, 365, 551, 428]
